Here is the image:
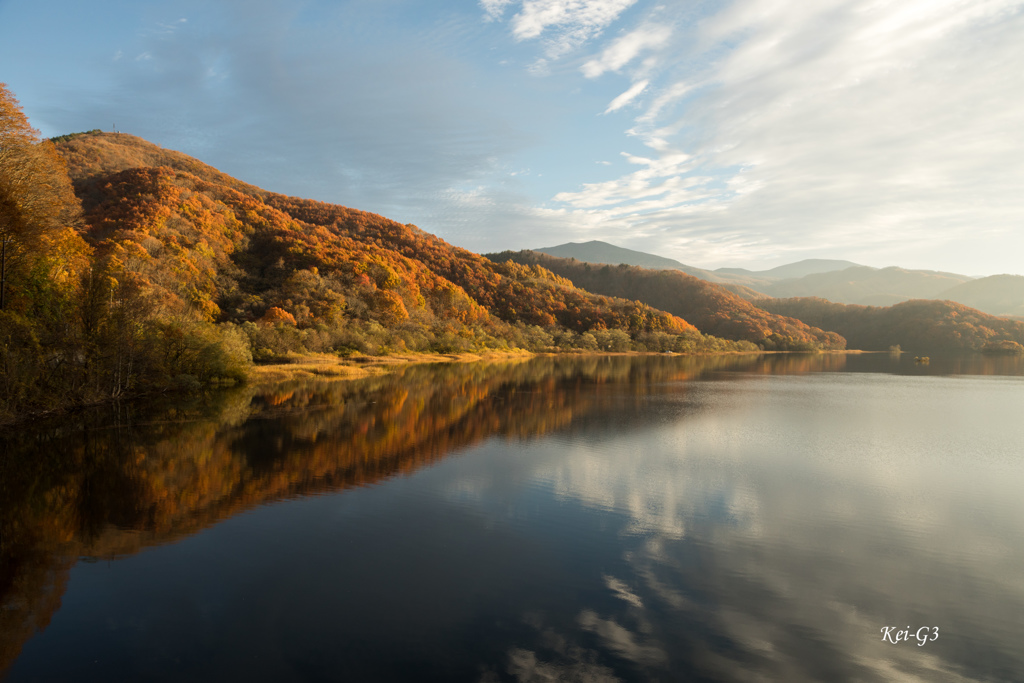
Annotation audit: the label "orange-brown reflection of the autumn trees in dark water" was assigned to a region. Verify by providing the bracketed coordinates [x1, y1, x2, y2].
[0, 356, 843, 669]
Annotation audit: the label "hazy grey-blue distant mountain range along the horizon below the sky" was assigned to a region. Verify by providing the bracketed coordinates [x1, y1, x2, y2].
[535, 241, 1024, 317]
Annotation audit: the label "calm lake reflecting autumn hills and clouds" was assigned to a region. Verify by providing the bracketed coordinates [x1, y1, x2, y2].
[0, 354, 1024, 682]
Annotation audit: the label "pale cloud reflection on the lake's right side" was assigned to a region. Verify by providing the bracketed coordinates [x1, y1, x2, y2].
[499, 376, 1024, 681]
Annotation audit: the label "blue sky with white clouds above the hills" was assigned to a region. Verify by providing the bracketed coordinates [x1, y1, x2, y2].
[0, 0, 1024, 275]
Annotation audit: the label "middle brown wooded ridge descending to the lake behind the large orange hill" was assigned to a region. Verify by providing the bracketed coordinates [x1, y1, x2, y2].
[489, 251, 845, 350]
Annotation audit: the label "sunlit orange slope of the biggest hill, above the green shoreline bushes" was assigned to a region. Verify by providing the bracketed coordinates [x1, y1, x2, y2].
[57, 133, 695, 346]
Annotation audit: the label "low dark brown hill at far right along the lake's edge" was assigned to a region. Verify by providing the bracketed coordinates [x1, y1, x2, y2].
[758, 298, 1024, 353]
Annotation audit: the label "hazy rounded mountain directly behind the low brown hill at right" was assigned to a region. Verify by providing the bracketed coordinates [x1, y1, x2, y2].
[760, 265, 971, 306]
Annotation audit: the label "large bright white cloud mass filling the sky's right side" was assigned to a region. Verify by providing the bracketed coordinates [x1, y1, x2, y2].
[554, 0, 1024, 271]
